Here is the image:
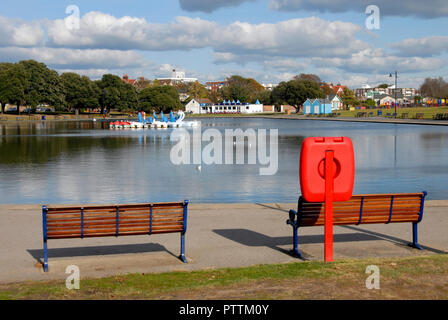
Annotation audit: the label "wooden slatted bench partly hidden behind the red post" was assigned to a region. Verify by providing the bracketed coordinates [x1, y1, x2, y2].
[286, 192, 427, 257]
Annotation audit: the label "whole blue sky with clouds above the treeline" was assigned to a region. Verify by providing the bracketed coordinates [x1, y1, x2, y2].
[0, 0, 448, 88]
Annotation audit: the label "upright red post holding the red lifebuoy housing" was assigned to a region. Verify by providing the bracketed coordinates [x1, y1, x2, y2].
[324, 150, 335, 262]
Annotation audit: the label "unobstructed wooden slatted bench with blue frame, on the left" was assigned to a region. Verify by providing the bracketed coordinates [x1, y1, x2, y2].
[42, 200, 188, 272]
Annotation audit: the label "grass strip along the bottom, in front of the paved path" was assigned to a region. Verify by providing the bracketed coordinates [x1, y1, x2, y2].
[0, 255, 448, 300]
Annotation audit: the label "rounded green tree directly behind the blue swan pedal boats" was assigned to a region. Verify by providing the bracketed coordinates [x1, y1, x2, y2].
[138, 86, 182, 113]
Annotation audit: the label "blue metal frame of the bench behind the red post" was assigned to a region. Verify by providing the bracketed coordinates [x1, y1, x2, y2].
[286, 191, 428, 259]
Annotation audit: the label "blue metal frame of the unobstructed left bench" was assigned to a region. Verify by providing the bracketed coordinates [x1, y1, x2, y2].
[42, 200, 189, 272]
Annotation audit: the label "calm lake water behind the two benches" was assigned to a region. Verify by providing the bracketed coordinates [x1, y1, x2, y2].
[0, 118, 448, 204]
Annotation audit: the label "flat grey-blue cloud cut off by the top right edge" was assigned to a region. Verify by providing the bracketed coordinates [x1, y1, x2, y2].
[270, 0, 448, 18]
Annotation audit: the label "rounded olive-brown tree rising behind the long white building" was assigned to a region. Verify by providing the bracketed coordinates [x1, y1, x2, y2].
[219, 76, 266, 103]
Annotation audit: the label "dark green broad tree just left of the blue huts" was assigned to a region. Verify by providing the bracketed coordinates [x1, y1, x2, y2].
[272, 79, 325, 109]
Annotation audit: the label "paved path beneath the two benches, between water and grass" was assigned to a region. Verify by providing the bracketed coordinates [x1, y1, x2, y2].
[0, 201, 448, 283]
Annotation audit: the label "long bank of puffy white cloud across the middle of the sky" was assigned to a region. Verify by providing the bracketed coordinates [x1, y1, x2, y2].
[48, 12, 367, 61]
